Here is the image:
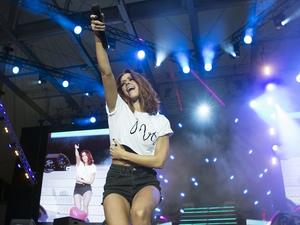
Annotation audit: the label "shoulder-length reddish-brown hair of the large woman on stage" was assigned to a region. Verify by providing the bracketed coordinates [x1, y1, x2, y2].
[117, 69, 160, 115]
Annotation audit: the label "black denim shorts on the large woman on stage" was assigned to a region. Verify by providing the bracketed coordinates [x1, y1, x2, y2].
[102, 164, 161, 204]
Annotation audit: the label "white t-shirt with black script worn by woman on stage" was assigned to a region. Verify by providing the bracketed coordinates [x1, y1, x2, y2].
[107, 95, 173, 155]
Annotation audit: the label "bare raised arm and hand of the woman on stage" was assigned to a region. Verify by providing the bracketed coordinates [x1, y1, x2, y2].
[91, 15, 118, 112]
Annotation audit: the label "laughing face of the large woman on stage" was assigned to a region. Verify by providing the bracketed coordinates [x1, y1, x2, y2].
[120, 73, 139, 101]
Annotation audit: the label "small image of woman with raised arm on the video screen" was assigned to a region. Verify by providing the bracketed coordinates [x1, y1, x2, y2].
[70, 144, 96, 219]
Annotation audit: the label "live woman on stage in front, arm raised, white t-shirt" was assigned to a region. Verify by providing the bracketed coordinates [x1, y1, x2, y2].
[91, 15, 173, 225]
